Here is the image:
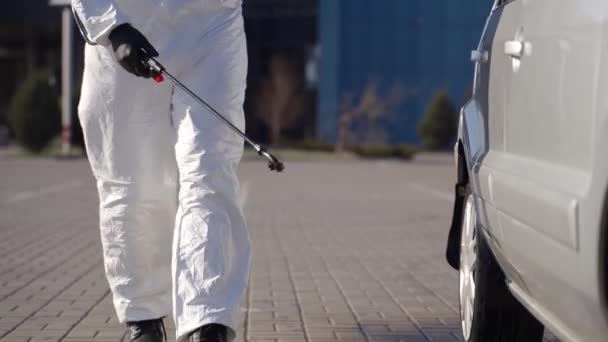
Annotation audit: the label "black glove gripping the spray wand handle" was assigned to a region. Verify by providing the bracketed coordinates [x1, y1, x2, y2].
[109, 24, 158, 78]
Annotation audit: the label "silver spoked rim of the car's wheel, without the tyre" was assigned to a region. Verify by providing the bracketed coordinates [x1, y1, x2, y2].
[459, 195, 477, 341]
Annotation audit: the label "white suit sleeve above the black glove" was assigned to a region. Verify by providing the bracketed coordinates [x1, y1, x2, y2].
[72, 0, 128, 45]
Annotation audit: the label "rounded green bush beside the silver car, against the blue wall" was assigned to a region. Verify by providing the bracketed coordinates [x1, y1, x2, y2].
[418, 90, 458, 150]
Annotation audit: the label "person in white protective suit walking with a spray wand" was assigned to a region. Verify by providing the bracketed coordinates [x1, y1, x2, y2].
[72, 0, 249, 342]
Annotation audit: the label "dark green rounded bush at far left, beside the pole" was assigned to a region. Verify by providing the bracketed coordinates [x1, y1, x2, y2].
[8, 71, 61, 152]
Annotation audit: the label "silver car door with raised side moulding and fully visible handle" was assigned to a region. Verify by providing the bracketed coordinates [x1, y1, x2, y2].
[490, 0, 602, 336]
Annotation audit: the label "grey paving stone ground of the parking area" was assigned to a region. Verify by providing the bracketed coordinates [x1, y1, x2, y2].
[0, 155, 560, 342]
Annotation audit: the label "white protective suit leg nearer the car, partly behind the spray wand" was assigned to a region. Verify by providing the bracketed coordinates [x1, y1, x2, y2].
[167, 12, 250, 339]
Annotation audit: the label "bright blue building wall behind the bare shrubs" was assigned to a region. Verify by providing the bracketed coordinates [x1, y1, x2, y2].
[318, 0, 493, 143]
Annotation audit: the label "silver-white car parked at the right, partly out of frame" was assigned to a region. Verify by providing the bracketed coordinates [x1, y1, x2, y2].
[446, 0, 608, 342]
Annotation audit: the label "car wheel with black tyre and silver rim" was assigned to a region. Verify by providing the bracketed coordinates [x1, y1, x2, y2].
[459, 187, 544, 342]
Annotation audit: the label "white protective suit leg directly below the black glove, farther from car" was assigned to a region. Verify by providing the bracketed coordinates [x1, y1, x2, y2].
[79, 42, 177, 322]
